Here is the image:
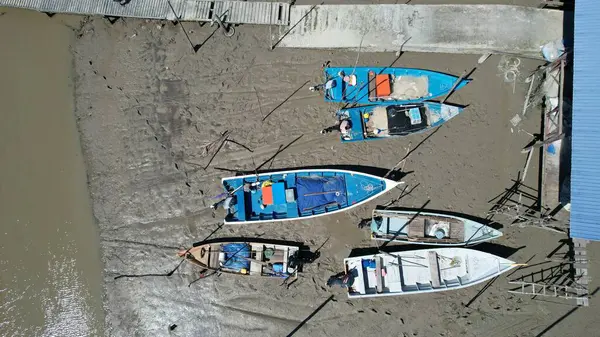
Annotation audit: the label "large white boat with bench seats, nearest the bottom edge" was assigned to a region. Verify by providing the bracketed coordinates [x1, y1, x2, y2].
[344, 247, 517, 298]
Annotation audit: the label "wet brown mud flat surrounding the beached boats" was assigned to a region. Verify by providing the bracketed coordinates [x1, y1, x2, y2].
[74, 11, 594, 336]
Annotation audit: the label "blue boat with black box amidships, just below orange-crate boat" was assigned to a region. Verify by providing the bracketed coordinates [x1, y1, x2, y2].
[337, 102, 463, 143]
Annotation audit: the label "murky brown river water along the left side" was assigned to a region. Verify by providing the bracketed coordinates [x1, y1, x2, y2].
[0, 8, 103, 337]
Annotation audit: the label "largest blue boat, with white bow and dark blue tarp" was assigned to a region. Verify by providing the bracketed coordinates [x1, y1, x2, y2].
[222, 170, 399, 223]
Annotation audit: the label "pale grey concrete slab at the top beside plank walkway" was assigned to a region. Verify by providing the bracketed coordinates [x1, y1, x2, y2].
[276, 5, 563, 56]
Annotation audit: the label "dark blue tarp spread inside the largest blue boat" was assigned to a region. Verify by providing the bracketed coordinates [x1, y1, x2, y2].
[296, 176, 347, 212]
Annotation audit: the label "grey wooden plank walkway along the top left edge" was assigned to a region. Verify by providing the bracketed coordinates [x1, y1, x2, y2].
[0, 0, 290, 26]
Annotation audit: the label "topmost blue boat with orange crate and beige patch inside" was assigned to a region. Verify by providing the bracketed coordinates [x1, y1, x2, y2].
[313, 67, 470, 104]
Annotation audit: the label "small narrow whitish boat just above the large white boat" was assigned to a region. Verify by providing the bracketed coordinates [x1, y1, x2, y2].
[371, 210, 502, 246]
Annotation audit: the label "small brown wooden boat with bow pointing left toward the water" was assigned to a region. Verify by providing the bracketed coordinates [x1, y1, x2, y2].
[178, 241, 300, 278]
